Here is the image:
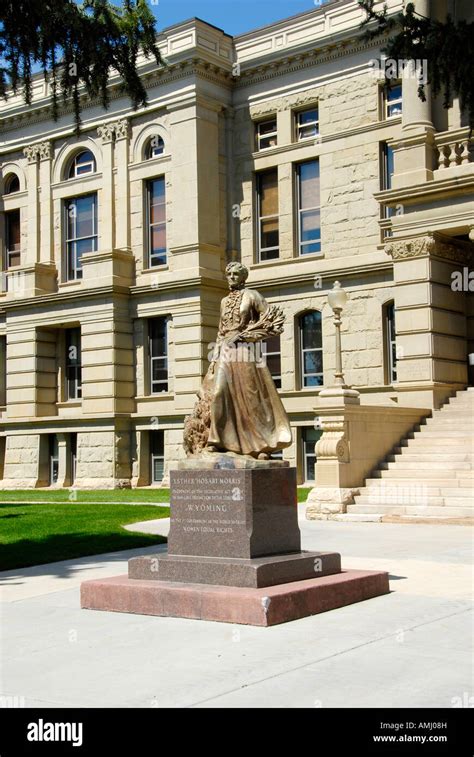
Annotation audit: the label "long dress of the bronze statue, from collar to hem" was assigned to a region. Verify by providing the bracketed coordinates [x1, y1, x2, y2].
[207, 289, 292, 456]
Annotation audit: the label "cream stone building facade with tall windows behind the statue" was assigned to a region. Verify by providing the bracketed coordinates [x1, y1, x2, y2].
[0, 0, 474, 489]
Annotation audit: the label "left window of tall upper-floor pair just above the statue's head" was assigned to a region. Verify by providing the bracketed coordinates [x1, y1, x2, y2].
[257, 168, 280, 261]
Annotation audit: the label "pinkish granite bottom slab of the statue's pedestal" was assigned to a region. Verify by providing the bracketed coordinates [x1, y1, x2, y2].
[81, 570, 390, 626]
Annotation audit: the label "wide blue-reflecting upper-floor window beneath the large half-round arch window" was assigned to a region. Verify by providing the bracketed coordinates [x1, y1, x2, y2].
[66, 193, 98, 280]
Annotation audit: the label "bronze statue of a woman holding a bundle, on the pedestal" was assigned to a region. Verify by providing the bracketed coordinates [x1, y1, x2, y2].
[184, 263, 291, 460]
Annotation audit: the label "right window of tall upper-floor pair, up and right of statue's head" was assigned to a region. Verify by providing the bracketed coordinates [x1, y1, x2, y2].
[297, 160, 321, 255]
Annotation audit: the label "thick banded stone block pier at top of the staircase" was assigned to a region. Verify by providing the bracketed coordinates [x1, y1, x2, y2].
[385, 233, 472, 407]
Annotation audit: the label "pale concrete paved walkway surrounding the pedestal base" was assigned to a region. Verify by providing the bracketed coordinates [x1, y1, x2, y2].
[0, 521, 473, 708]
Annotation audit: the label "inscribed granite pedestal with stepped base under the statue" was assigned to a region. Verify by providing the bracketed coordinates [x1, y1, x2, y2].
[81, 458, 389, 625]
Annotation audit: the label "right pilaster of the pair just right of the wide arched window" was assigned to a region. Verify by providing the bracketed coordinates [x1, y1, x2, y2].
[114, 119, 130, 250]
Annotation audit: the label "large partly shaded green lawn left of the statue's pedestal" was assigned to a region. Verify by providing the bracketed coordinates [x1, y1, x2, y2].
[0, 504, 169, 570]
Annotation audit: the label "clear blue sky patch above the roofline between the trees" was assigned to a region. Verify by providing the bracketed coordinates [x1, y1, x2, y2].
[148, 0, 322, 36]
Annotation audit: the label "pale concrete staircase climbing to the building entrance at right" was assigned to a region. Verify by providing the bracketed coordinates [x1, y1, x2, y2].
[344, 387, 474, 521]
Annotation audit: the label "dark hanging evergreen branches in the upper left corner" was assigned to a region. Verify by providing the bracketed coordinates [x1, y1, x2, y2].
[0, 0, 163, 128]
